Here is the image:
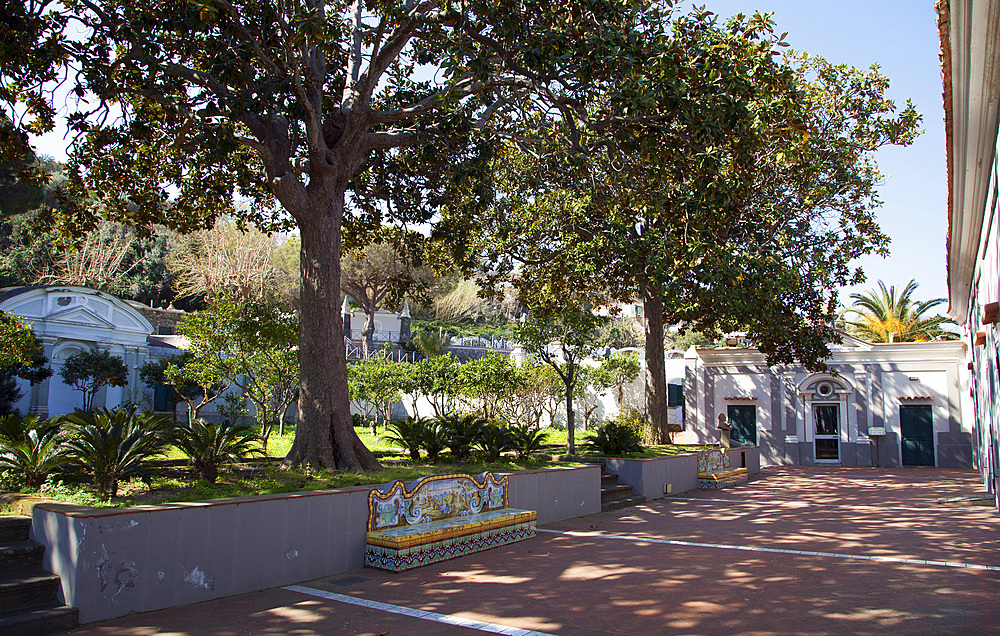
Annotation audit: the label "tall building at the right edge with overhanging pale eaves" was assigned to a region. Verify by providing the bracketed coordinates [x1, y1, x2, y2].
[938, 0, 1000, 506]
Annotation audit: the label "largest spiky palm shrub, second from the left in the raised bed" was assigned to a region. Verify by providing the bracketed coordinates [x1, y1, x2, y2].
[63, 407, 173, 497]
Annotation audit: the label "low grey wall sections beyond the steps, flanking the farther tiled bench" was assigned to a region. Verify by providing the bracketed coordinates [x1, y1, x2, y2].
[607, 446, 760, 499]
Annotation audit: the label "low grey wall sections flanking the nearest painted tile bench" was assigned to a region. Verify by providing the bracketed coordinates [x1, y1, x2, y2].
[31, 466, 601, 623]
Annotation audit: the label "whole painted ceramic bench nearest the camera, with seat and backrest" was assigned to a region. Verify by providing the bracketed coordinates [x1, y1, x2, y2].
[365, 472, 537, 572]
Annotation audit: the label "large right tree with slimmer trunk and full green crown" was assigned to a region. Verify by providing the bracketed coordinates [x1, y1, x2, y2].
[468, 10, 919, 441]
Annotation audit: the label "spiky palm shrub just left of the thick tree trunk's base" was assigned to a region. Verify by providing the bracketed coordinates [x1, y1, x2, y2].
[171, 418, 264, 484]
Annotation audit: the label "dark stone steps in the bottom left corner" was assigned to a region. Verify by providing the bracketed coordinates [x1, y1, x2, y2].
[0, 516, 79, 636]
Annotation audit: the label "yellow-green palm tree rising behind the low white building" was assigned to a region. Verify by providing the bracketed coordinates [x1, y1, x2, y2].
[844, 279, 955, 342]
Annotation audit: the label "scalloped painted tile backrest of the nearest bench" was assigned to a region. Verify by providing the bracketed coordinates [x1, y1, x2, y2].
[368, 472, 507, 532]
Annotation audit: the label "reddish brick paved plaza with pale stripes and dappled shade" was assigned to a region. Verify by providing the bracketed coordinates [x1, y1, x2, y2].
[66, 467, 1000, 636]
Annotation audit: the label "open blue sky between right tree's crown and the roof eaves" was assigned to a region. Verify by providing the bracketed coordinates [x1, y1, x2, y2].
[698, 0, 948, 303]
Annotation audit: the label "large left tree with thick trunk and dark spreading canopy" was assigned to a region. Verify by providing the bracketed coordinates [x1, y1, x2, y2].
[0, 0, 657, 469]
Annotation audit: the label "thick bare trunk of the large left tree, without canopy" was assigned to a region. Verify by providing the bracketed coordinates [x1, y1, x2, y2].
[282, 189, 381, 471]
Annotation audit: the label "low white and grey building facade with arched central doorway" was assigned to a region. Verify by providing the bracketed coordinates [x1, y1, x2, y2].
[684, 335, 972, 467]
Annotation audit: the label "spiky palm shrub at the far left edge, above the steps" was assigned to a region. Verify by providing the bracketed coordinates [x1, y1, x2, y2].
[0, 416, 69, 488]
